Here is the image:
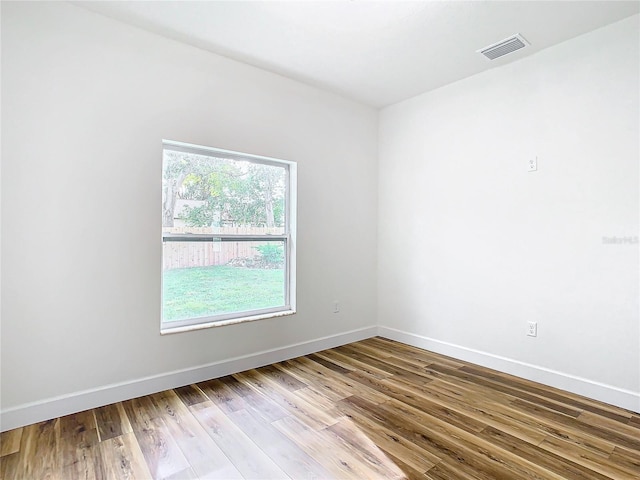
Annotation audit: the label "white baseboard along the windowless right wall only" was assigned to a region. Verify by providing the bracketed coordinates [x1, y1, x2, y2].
[378, 326, 640, 413]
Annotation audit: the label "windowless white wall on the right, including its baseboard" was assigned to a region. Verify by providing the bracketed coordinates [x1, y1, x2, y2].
[378, 16, 640, 411]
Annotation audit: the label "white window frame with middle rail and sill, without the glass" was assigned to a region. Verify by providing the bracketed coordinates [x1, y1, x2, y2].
[160, 140, 297, 334]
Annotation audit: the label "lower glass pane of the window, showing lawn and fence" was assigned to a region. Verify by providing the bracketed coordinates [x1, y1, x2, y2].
[162, 240, 286, 322]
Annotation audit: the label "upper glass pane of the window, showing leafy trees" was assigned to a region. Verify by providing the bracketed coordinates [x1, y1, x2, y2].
[162, 149, 287, 235]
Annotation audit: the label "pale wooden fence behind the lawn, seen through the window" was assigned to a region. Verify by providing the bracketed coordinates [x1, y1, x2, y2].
[162, 227, 281, 270]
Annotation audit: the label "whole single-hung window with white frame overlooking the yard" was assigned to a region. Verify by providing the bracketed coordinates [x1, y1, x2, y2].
[161, 141, 296, 333]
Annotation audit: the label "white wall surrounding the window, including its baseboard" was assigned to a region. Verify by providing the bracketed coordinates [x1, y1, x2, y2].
[1, 2, 377, 429]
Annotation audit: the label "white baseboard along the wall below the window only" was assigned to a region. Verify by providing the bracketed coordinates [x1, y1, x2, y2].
[0, 326, 377, 432]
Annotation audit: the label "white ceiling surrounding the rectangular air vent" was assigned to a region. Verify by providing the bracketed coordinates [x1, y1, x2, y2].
[73, 0, 640, 107]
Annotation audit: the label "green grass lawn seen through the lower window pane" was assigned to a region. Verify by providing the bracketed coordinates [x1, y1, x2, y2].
[162, 265, 284, 322]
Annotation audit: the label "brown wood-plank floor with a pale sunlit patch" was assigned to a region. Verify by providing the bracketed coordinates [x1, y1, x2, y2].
[0, 338, 640, 480]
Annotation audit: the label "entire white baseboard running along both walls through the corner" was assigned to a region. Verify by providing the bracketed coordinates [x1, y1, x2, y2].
[0, 326, 640, 431]
